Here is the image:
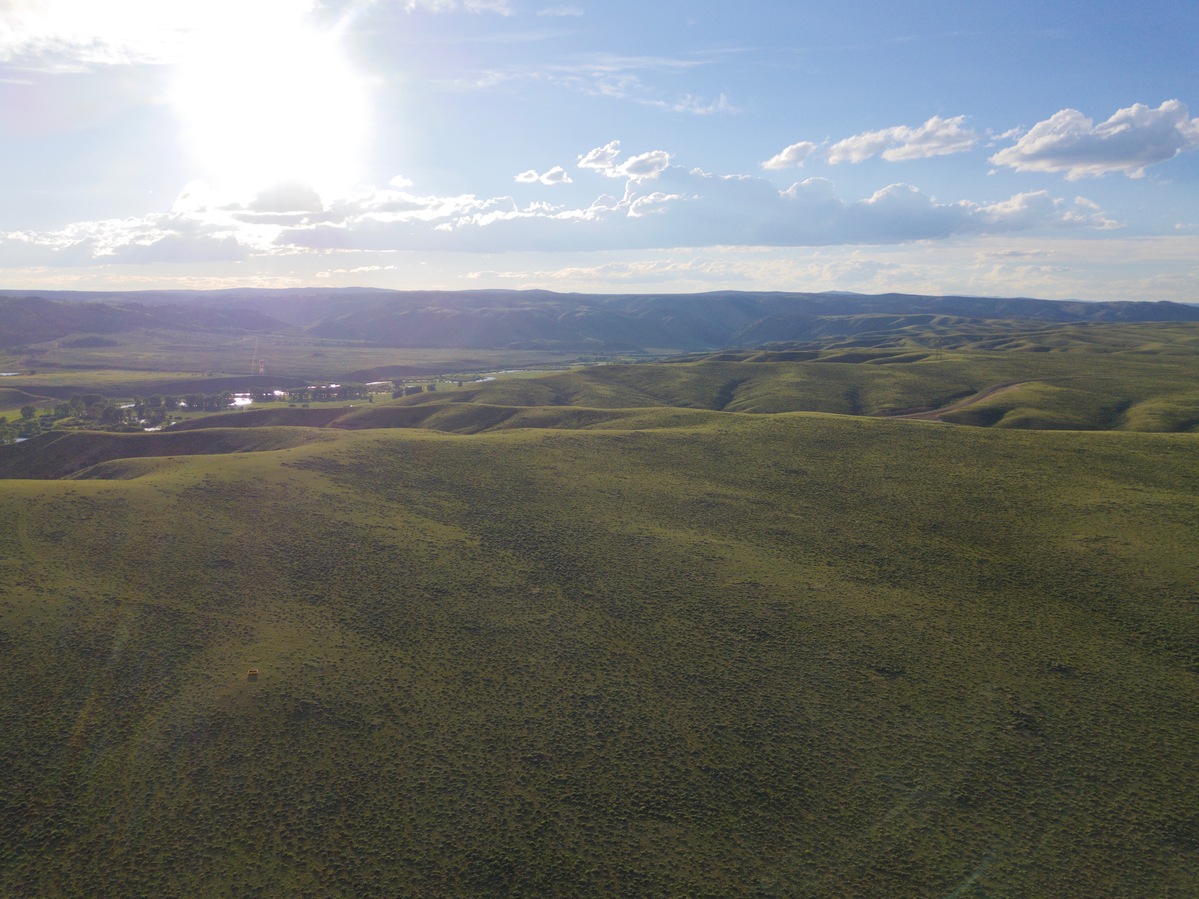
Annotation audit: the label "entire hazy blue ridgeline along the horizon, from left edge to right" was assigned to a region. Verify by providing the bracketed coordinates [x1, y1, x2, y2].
[0, 288, 1199, 352]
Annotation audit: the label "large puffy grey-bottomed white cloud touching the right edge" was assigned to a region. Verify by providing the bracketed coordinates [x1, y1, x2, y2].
[990, 99, 1199, 181]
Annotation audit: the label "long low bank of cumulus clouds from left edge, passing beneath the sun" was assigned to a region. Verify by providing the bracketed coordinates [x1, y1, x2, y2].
[0, 141, 1116, 266]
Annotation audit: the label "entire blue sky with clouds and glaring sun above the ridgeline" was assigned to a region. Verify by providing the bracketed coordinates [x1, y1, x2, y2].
[0, 0, 1199, 302]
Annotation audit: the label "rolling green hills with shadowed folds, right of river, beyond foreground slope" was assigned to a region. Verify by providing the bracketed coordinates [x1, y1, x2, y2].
[381, 324, 1199, 432]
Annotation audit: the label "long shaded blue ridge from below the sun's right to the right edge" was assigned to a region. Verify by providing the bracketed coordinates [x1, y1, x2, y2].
[297, 291, 1199, 351]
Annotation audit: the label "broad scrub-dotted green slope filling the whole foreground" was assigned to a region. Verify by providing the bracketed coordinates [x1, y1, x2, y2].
[0, 419, 1199, 897]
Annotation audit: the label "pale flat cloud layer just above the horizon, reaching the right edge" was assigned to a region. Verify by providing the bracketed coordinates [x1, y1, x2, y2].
[455, 234, 1199, 302]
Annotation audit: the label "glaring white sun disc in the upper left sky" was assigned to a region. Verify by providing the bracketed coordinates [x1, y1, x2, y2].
[173, 14, 369, 197]
